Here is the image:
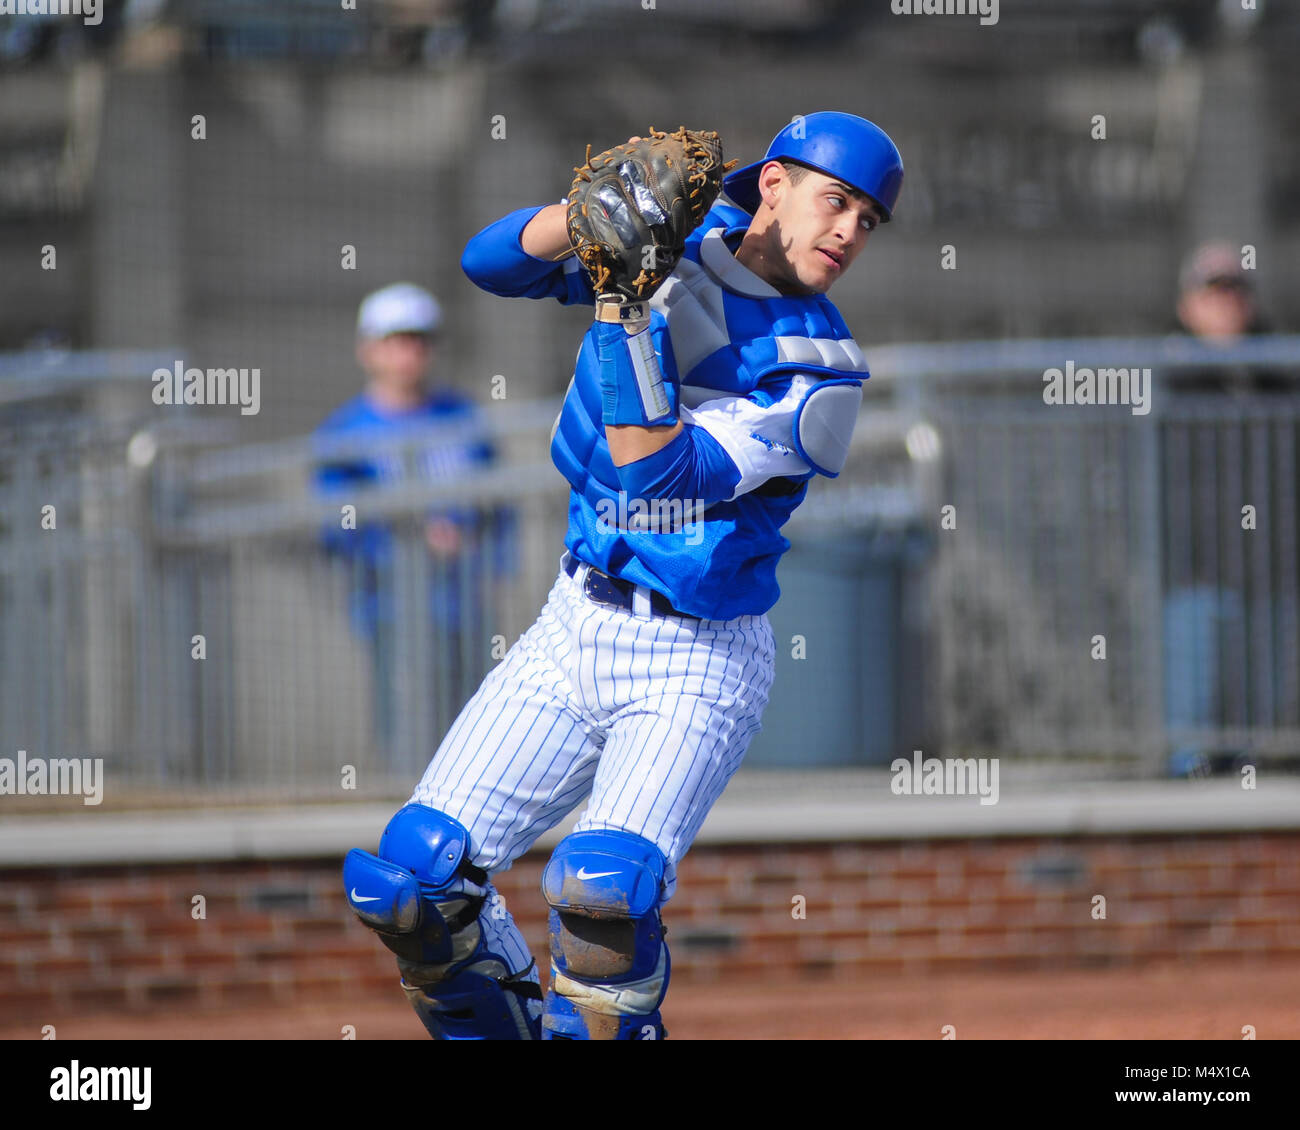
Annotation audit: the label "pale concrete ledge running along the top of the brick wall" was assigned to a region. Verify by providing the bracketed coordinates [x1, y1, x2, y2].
[0, 772, 1300, 869]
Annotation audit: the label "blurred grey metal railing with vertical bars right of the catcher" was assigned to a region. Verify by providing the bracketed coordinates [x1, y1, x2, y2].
[871, 335, 1300, 772]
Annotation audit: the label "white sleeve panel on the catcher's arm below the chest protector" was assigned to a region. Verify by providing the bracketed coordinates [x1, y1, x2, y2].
[679, 373, 862, 499]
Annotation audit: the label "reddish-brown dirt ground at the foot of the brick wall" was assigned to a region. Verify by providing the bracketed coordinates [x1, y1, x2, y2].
[0, 962, 1300, 1040]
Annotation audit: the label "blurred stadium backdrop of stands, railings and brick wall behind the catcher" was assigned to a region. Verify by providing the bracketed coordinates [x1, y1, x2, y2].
[0, 0, 1300, 1038]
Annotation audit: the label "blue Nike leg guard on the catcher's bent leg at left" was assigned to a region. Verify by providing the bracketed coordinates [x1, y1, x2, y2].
[343, 805, 541, 1040]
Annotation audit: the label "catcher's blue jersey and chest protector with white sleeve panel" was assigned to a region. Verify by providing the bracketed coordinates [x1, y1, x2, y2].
[462, 199, 868, 620]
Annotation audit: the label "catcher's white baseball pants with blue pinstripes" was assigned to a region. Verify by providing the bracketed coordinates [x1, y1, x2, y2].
[411, 556, 775, 975]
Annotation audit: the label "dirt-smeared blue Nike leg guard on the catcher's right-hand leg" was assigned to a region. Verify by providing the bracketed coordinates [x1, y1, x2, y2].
[542, 831, 670, 1040]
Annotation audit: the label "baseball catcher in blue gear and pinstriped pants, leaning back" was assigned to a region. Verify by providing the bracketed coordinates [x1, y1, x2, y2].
[343, 112, 902, 1040]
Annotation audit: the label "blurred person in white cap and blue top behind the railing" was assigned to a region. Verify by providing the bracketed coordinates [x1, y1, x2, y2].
[316, 282, 503, 766]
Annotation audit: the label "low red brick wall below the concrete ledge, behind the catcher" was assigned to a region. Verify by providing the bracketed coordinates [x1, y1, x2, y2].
[0, 834, 1300, 1023]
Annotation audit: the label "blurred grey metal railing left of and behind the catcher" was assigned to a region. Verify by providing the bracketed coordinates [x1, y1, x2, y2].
[0, 358, 935, 798]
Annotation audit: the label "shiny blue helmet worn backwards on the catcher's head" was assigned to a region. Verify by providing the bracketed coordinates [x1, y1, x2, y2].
[723, 111, 902, 221]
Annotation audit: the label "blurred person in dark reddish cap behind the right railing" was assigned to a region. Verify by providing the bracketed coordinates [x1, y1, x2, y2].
[1164, 242, 1294, 776]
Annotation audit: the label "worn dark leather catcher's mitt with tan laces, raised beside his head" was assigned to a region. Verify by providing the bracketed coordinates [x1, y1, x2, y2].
[568, 126, 736, 302]
